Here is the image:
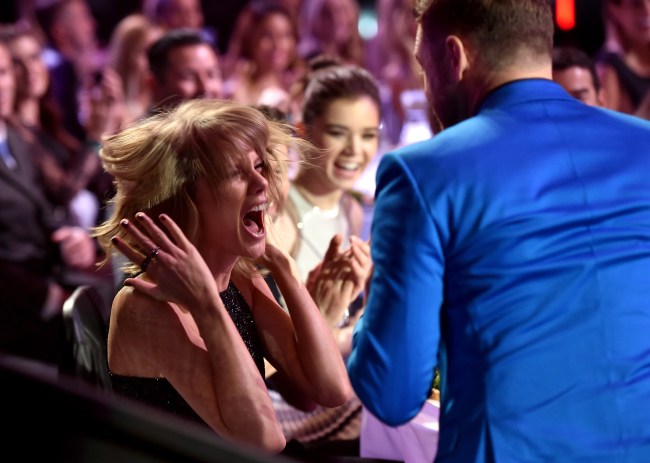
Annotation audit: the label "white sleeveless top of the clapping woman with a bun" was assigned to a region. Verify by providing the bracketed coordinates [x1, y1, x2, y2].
[289, 185, 351, 281]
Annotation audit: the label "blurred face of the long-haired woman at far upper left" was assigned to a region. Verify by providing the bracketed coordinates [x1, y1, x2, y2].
[9, 35, 49, 101]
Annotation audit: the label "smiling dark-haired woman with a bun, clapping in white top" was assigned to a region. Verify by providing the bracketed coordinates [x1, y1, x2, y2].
[273, 60, 381, 454]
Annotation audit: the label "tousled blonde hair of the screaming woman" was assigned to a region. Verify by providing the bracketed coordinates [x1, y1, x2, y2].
[95, 100, 304, 275]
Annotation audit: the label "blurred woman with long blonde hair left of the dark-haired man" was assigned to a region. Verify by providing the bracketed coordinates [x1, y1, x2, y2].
[107, 13, 163, 123]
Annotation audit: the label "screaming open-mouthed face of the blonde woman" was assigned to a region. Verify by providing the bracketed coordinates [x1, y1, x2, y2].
[196, 151, 268, 259]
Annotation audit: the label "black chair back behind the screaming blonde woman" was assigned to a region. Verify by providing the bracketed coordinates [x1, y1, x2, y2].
[59, 285, 112, 390]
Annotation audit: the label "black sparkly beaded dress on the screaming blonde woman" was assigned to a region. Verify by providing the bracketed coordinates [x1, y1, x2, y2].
[111, 282, 264, 425]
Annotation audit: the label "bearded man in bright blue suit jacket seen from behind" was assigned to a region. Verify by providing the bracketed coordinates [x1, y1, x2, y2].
[348, 0, 650, 463]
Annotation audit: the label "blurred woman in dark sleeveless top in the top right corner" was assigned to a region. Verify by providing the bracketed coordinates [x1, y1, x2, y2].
[596, 0, 650, 119]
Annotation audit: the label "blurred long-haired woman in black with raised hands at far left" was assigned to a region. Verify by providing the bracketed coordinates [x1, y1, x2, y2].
[0, 24, 123, 228]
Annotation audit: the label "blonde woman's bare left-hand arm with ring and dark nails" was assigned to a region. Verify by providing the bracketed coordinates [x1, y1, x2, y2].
[109, 214, 285, 452]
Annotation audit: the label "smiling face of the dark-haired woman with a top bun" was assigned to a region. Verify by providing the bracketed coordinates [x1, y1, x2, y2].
[305, 96, 380, 194]
